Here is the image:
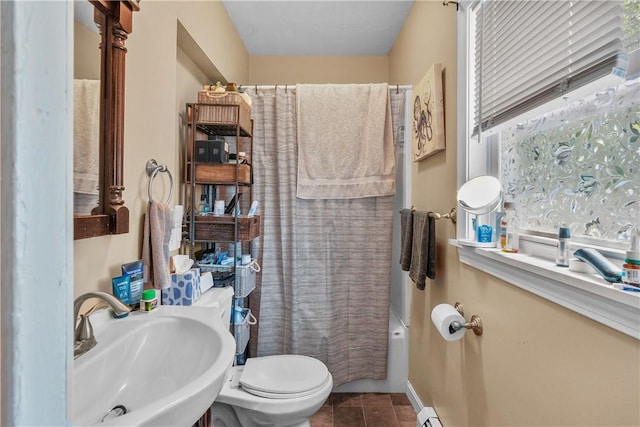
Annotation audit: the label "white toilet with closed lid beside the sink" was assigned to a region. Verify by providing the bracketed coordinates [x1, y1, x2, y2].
[194, 287, 333, 427]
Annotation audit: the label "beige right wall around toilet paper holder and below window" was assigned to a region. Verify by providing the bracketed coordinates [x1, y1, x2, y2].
[389, 2, 640, 427]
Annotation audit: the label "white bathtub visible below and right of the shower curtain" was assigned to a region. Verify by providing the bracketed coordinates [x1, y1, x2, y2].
[333, 308, 409, 393]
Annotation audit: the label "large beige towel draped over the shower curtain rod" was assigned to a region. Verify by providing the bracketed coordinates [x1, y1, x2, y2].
[296, 83, 395, 199]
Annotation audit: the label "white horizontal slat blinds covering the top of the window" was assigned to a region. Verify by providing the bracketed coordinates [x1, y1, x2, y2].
[473, 0, 626, 132]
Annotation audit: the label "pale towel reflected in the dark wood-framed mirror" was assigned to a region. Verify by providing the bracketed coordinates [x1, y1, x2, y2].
[73, 79, 100, 194]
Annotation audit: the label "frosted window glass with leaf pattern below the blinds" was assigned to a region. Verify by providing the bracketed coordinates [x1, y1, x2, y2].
[500, 78, 640, 241]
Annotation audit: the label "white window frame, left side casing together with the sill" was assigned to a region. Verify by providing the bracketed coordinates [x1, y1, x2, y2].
[450, 2, 640, 340]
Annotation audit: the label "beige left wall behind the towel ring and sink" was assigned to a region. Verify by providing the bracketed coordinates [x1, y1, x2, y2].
[74, 0, 249, 296]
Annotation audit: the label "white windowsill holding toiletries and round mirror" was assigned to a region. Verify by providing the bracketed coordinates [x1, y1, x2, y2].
[449, 238, 640, 340]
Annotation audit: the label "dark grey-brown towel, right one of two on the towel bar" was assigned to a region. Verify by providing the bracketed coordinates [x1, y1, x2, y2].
[409, 212, 436, 290]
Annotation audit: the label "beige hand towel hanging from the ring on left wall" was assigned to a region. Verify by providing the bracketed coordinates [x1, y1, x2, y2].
[142, 202, 173, 289]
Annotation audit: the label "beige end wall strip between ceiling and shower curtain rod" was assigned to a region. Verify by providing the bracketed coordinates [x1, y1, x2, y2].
[249, 55, 389, 85]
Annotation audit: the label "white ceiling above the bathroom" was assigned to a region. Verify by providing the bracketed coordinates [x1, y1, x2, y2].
[223, 0, 413, 55]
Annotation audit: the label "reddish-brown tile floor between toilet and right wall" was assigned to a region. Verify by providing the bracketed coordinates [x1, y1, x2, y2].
[311, 393, 416, 427]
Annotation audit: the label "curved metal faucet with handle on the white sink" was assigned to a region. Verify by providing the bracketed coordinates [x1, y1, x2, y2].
[73, 292, 131, 359]
